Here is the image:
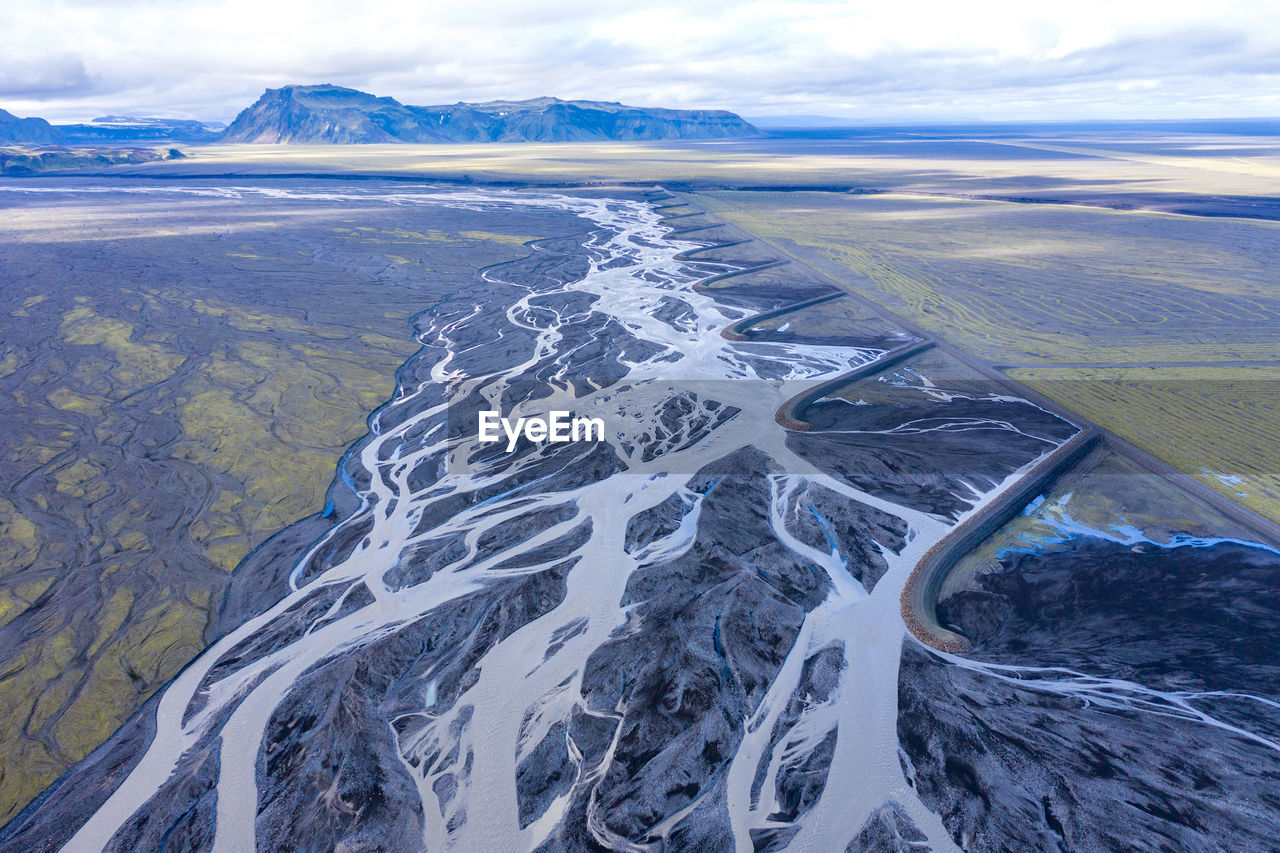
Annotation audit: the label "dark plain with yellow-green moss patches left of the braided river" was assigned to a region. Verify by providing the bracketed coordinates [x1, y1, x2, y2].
[0, 185, 563, 822]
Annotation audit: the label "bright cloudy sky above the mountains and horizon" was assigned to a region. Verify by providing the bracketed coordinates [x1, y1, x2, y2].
[0, 0, 1280, 122]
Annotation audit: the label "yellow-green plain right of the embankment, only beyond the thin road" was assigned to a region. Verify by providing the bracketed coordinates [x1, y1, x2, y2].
[692, 192, 1280, 364]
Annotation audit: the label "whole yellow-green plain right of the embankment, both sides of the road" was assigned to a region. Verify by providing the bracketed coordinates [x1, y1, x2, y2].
[690, 191, 1280, 520]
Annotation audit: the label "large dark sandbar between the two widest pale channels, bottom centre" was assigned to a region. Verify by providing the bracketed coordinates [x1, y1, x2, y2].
[545, 450, 834, 850]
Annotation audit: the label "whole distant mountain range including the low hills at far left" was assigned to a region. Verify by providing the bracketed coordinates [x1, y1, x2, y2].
[0, 85, 760, 146]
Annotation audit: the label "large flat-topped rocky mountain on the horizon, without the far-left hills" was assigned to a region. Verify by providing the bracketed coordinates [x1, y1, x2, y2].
[220, 85, 759, 143]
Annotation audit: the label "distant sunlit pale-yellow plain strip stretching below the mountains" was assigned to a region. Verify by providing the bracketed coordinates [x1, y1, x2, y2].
[107, 133, 1280, 205]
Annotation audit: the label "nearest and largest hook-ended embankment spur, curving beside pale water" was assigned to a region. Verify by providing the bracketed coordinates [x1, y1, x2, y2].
[900, 427, 1102, 654]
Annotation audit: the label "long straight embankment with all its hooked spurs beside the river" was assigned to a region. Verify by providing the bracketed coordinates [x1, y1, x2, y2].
[668, 191, 1280, 652]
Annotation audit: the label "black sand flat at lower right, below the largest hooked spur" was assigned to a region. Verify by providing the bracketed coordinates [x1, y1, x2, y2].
[899, 538, 1280, 850]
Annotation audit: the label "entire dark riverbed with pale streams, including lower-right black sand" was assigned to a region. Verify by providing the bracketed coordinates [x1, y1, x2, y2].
[0, 174, 1280, 852]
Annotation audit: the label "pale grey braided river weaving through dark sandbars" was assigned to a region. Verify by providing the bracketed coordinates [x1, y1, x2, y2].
[37, 188, 1280, 853]
